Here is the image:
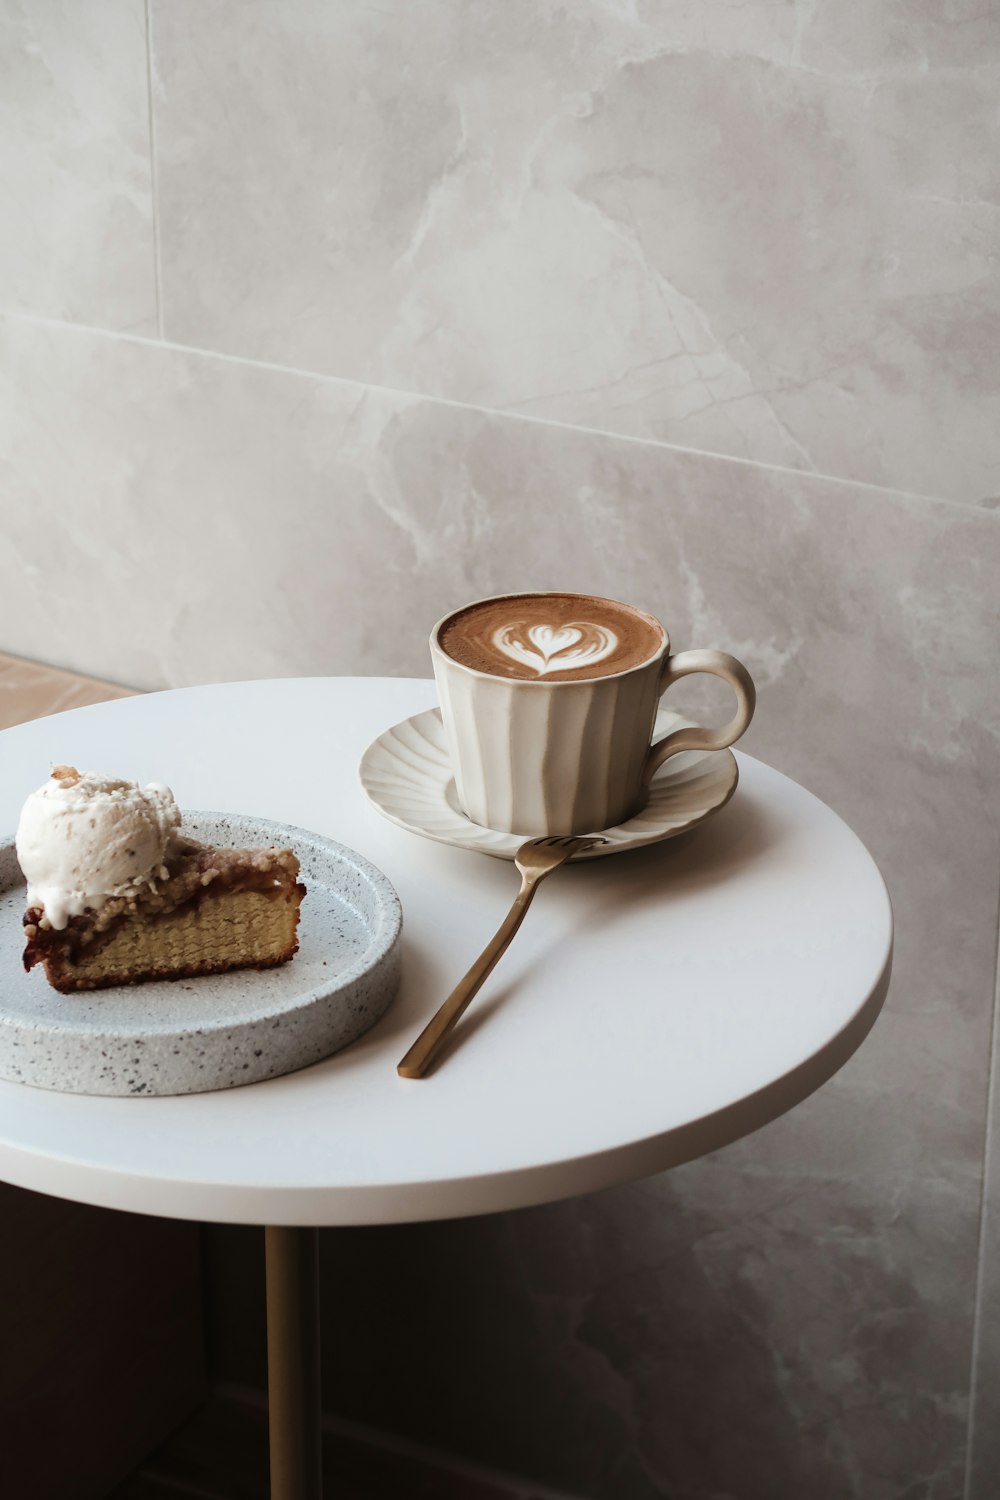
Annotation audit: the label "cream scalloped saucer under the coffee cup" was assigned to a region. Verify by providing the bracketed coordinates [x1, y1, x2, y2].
[358, 708, 739, 860]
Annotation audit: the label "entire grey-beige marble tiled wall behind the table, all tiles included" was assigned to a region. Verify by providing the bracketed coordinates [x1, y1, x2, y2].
[0, 0, 1000, 1500]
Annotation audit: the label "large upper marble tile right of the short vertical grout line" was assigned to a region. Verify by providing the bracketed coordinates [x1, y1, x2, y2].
[151, 0, 1000, 501]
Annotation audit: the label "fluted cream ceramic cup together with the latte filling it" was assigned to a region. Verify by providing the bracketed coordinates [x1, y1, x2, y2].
[430, 594, 756, 837]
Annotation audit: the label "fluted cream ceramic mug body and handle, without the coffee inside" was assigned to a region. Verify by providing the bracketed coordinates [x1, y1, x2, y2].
[430, 593, 756, 837]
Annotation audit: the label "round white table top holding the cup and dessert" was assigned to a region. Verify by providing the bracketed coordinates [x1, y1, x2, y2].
[0, 678, 892, 1224]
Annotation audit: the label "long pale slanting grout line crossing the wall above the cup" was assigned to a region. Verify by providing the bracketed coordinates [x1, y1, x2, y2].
[0, 306, 983, 522]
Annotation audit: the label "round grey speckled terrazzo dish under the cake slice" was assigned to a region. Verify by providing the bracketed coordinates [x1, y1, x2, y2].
[0, 813, 402, 1095]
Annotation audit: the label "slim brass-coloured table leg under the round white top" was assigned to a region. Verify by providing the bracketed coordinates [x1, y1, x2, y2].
[264, 1224, 322, 1500]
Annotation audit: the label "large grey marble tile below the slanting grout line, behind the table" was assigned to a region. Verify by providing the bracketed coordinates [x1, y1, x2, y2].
[0, 320, 1000, 1500]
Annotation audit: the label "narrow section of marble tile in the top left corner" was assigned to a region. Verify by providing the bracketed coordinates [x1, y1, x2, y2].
[0, 0, 157, 335]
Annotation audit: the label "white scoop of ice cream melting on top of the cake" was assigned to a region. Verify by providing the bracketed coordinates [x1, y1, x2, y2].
[16, 765, 180, 929]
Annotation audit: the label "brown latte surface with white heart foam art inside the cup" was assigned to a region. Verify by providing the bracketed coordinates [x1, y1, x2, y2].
[439, 594, 664, 683]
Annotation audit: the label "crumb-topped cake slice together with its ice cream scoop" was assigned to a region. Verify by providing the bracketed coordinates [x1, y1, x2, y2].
[16, 767, 306, 993]
